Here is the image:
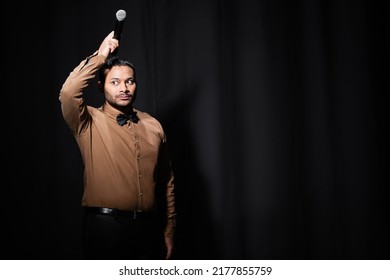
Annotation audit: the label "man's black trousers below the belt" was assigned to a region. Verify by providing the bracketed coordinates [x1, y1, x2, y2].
[82, 211, 166, 260]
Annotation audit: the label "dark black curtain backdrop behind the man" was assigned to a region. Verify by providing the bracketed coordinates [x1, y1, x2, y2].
[0, 0, 390, 259]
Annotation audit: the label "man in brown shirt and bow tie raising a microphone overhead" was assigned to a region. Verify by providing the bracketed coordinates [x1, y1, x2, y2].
[59, 31, 176, 259]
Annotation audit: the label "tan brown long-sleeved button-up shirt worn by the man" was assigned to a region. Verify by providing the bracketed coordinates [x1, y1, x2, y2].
[59, 53, 175, 236]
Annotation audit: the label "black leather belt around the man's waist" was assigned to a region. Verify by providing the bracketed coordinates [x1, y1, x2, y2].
[84, 207, 158, 221]
